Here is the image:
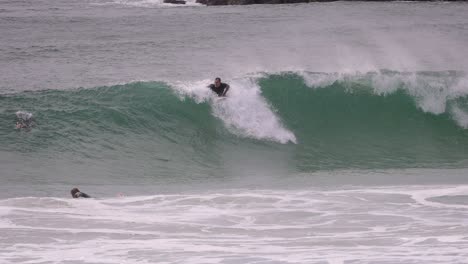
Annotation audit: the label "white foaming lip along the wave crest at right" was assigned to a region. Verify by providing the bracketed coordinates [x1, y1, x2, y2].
[299, 71, 468, 127]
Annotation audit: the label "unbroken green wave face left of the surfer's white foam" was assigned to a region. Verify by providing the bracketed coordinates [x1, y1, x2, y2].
[0, 82, 227, 178]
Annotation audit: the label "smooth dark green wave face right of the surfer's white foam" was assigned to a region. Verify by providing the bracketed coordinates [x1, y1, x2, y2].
[260, 74, 468, 171]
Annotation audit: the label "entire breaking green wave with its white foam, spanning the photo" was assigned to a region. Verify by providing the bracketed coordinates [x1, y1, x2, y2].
[0, 72, 468, 177]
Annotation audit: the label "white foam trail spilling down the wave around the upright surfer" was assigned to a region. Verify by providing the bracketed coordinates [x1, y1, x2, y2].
[175, 78, 297, 144]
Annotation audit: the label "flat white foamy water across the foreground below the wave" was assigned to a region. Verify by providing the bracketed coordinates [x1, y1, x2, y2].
[0, 185, 468, 264]
